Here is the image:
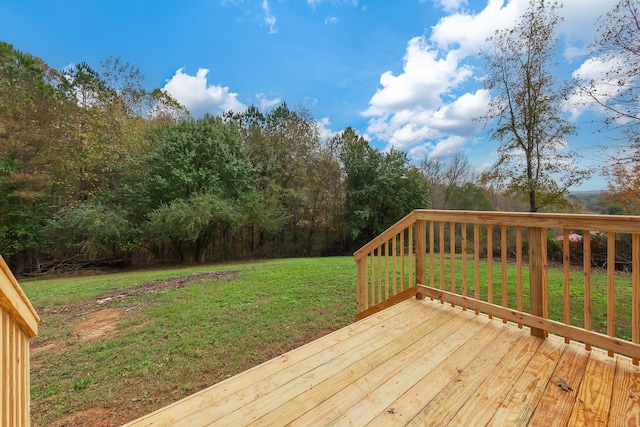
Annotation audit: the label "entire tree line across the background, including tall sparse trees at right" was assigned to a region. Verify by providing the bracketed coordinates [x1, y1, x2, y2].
[0, 0, 640, 274]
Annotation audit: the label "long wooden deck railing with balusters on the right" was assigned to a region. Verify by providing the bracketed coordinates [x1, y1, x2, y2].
[354, 210, 640, 365]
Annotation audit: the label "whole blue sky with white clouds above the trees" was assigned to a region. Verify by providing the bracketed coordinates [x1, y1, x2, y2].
[0, 0, 615, 190]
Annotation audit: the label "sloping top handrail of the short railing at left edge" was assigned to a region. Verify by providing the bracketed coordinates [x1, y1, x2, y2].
[0, 255, 40, 338]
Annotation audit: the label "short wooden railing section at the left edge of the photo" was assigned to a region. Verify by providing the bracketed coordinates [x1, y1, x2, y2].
[0, 256, 40, 426]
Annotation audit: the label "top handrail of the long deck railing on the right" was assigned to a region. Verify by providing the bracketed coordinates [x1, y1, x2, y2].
[353, 209, 640, 261]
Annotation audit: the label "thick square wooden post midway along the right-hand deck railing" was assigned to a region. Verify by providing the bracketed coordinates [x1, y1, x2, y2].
[529, 227, 547, 338]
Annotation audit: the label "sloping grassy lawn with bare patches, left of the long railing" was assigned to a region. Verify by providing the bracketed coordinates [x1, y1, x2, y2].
[22, 257, 355, 425]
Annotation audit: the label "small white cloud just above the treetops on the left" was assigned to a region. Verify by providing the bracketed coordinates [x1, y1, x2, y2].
[163, 68, 247, 117]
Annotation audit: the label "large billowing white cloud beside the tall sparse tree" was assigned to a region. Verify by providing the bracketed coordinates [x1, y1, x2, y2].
[362, 0, 615, 162]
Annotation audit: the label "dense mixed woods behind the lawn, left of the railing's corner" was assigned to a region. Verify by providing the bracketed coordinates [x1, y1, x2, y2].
[0, 43, 438, 274]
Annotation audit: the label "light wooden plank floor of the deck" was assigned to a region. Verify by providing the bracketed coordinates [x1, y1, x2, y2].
[122, 299, 640, 426]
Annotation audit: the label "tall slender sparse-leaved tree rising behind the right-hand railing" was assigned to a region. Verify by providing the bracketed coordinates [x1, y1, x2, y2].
[482, 0, 589, 212]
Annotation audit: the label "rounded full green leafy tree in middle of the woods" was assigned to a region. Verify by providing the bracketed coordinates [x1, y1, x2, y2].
[125, 116, 257, 261]
